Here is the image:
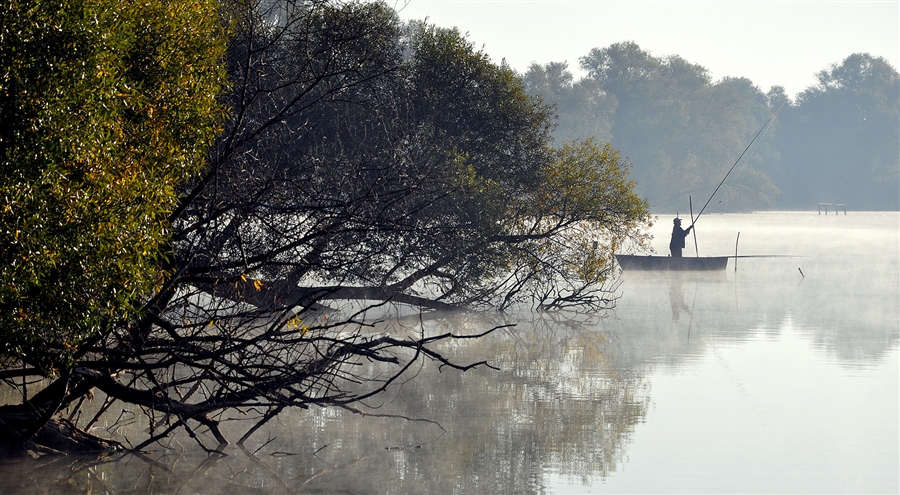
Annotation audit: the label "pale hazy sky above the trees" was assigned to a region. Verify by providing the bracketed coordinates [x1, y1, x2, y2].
[389, 0, 900, 97]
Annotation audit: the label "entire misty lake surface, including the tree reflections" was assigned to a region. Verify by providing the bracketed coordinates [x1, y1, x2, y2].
[0, 211, 900, 494]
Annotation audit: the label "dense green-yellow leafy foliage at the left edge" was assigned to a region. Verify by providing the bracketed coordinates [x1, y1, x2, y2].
[0, 0, 224, 373]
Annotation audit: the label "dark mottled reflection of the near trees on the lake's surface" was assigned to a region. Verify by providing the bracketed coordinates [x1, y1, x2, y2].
[0, 315, 649, 493]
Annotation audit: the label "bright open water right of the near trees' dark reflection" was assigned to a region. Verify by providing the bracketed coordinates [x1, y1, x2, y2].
[594, 212, 900, 493]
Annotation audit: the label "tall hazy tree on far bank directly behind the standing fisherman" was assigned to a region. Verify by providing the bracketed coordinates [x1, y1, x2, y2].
[581, 42, 778, 210]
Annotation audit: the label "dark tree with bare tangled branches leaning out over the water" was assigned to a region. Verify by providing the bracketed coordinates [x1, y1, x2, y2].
[0, 1, 648, 456]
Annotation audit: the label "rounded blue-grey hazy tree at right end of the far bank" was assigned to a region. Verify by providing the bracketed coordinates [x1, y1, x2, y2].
[771, 53, 900, 210]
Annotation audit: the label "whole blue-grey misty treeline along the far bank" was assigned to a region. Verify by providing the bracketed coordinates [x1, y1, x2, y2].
[523, 42, 900, 212]
